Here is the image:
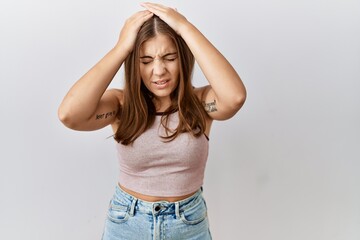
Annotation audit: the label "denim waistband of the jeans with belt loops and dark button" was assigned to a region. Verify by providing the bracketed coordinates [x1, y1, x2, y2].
[114, 185, 203, 218]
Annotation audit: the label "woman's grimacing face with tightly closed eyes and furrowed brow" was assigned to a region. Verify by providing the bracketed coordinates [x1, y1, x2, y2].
[140, 34, 179, 106]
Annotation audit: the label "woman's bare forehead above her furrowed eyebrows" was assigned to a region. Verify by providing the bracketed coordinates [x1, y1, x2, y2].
[140, 34, 176, 56]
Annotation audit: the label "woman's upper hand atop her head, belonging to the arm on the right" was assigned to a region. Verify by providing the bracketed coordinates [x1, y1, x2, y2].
[141, 2, 189, 36]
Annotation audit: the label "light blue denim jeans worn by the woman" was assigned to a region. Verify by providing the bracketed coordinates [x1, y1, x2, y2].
[102, 186, 211, 240]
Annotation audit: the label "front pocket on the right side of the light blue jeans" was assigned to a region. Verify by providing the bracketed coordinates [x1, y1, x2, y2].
[180, 200, 207, 225]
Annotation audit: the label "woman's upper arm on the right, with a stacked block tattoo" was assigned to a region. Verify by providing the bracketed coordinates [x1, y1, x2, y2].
[194, 85, 245, 120]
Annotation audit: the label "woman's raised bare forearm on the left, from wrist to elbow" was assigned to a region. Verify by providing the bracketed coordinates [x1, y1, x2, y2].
[59, 47, 126, 119]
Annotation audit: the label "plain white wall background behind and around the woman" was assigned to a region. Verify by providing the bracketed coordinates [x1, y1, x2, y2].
[0, 0, 360, 240]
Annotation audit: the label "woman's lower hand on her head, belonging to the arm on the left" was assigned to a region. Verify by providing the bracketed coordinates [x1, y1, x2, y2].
[116, 10, 154, 54]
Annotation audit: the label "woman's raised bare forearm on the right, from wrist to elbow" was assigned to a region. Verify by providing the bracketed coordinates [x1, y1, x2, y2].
[181, 23, 246, 105]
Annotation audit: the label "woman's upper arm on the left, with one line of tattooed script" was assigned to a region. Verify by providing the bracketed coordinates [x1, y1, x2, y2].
[69, 89, 123, 131]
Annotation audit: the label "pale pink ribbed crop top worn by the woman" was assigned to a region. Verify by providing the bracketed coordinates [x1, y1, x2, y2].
[116, 112, 209, 197]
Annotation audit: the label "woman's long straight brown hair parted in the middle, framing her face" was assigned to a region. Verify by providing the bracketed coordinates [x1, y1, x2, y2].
[114, 16, 206, 145]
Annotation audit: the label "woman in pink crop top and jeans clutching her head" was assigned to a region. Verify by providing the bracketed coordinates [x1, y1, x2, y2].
[59, 3, 246, 240]
